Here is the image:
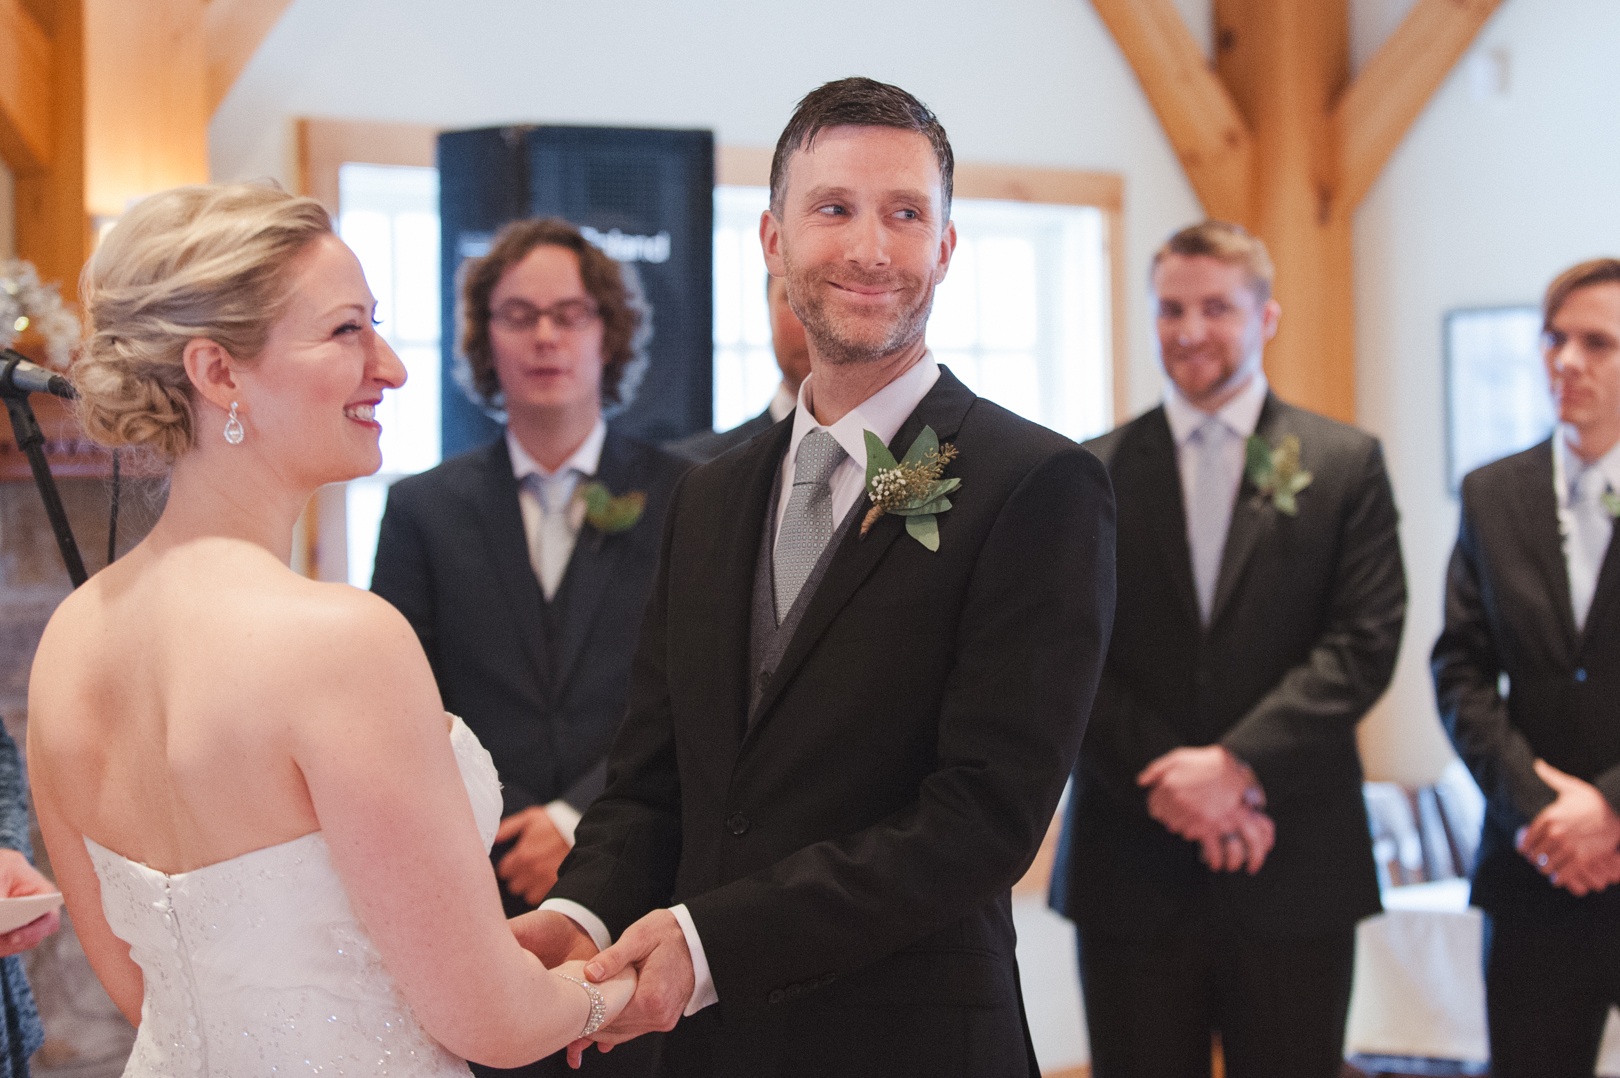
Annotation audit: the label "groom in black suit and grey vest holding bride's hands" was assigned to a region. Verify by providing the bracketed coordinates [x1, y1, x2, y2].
[518, 78, 1115, 1078]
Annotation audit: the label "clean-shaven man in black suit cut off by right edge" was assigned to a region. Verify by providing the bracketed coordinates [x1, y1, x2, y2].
[1434, 258, 1620, 1078]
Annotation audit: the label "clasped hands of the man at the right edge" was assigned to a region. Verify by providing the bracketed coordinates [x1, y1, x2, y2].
[1516, 760, 1620, 898]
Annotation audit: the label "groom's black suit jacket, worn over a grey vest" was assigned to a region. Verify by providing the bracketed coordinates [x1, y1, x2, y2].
[552, 371, 1113, 1075]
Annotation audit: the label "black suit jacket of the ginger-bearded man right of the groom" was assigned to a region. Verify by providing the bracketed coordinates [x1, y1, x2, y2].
[1053, 396, 1406, 937]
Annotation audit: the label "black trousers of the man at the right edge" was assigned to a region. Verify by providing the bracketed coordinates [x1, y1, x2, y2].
[1486, 916, 1620, 1078]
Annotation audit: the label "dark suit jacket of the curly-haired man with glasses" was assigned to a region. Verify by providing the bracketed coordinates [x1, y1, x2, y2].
[371, 431, 689, 815]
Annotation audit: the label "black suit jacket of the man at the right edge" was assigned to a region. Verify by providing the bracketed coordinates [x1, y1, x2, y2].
[1432, 439, 1620, 924]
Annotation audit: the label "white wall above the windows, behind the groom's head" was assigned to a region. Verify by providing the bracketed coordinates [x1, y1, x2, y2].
[209, 0, 1209, 407]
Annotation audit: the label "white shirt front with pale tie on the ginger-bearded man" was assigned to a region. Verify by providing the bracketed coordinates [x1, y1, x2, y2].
[1165, 371, 1267, 621]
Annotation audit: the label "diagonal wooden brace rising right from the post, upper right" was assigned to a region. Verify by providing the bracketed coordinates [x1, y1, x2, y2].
[1332, 0, 1502, 214]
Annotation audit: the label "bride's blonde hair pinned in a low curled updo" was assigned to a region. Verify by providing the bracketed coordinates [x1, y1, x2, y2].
[73, 183, 332, 460]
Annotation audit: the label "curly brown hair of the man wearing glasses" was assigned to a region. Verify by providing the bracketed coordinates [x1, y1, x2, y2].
[457, 217, 653, 415]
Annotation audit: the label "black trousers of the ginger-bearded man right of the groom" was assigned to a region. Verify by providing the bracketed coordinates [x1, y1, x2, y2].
[1079, 918, 1356, 1078]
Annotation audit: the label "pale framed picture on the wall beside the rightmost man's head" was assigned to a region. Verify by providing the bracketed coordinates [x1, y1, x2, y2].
[1445, 306, 1554, 494]
